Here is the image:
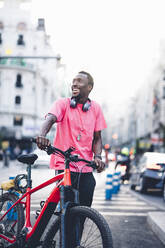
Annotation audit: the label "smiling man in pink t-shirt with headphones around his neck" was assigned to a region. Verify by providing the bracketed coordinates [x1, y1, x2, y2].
[37, 71, 106, 206]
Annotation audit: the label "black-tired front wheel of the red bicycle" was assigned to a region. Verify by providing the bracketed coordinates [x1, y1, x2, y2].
[42, 206, 113, 248]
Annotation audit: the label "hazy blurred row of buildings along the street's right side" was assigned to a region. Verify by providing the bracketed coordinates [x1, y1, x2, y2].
[109, 41, 165, 153]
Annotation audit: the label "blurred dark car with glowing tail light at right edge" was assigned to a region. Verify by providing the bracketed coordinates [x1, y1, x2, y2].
[130, 152, 165, 193]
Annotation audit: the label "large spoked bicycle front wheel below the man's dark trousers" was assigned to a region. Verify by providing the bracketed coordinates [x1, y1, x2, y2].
[42, 206, 113, 248]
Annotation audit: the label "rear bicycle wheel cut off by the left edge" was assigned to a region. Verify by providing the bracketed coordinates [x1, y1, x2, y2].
[0, 193, 25, 247]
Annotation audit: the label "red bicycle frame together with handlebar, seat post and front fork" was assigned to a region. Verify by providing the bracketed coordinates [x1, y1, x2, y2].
[0, 143, 96, 248]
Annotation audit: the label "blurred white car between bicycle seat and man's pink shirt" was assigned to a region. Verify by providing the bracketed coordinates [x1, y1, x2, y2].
[33, 149, 50, 168]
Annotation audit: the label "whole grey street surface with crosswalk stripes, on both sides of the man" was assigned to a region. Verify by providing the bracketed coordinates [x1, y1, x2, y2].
[1, 162, 165, 248]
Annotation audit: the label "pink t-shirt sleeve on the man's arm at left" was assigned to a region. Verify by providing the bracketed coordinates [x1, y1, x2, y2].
[48, 98, 67, 122]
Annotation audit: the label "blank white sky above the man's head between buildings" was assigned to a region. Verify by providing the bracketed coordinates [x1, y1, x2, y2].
[32, 0, 165, 106]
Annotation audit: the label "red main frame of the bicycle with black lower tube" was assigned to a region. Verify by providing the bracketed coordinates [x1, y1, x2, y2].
[0, 171, 65, 244]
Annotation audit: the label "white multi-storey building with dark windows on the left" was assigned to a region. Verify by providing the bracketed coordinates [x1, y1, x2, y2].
[0, 0, 66, 155]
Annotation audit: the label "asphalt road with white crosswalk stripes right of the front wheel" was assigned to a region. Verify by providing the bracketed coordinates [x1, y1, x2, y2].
[93, 185, 164, 248]
